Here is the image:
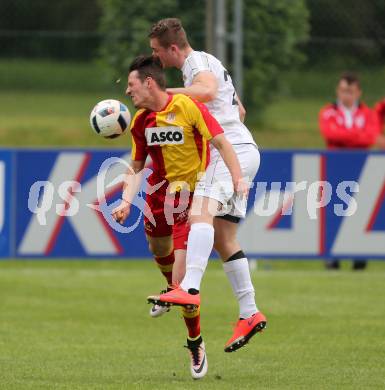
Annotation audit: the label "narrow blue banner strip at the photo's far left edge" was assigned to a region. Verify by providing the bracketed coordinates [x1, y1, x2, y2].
[0, 150, 13, 258]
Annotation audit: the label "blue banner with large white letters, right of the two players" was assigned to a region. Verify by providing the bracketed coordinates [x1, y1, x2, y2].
[239, 151, 385, 259]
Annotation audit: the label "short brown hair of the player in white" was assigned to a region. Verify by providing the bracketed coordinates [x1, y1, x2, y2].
[148, 18, 189, 49]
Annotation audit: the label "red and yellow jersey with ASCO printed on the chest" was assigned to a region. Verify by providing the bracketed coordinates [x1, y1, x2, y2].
[131, 94, 223, 191]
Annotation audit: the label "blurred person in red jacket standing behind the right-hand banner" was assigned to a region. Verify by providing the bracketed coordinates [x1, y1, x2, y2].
[319, 72, 380, 269]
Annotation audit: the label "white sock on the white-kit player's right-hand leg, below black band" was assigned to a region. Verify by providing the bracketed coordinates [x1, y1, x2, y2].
[223, 258, 259, 318]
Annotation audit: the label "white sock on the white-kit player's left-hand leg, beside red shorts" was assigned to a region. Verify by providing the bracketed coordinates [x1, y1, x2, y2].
[180, 223, 214, 291]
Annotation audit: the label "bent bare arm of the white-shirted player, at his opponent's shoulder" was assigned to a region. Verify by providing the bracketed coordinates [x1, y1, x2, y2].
[167, 71, 218, 103]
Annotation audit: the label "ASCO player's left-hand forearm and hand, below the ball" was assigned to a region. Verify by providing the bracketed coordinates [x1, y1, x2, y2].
[112, 160, 145, 224]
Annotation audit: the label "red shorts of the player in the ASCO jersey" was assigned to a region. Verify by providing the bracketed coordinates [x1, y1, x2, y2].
[144, 185, 193, 249]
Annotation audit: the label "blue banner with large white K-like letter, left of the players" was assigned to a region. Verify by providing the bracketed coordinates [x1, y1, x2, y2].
[16, 150, 150, 258]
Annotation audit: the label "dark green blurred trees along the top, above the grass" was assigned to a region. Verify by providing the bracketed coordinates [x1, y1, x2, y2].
[0, 0, 385, 114]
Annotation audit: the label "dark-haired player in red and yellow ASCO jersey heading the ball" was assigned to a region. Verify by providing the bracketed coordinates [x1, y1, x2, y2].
[113, 56, 247, 378]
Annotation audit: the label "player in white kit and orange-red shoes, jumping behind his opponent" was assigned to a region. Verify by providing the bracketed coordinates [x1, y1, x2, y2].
[149, 18, 266, 352]
